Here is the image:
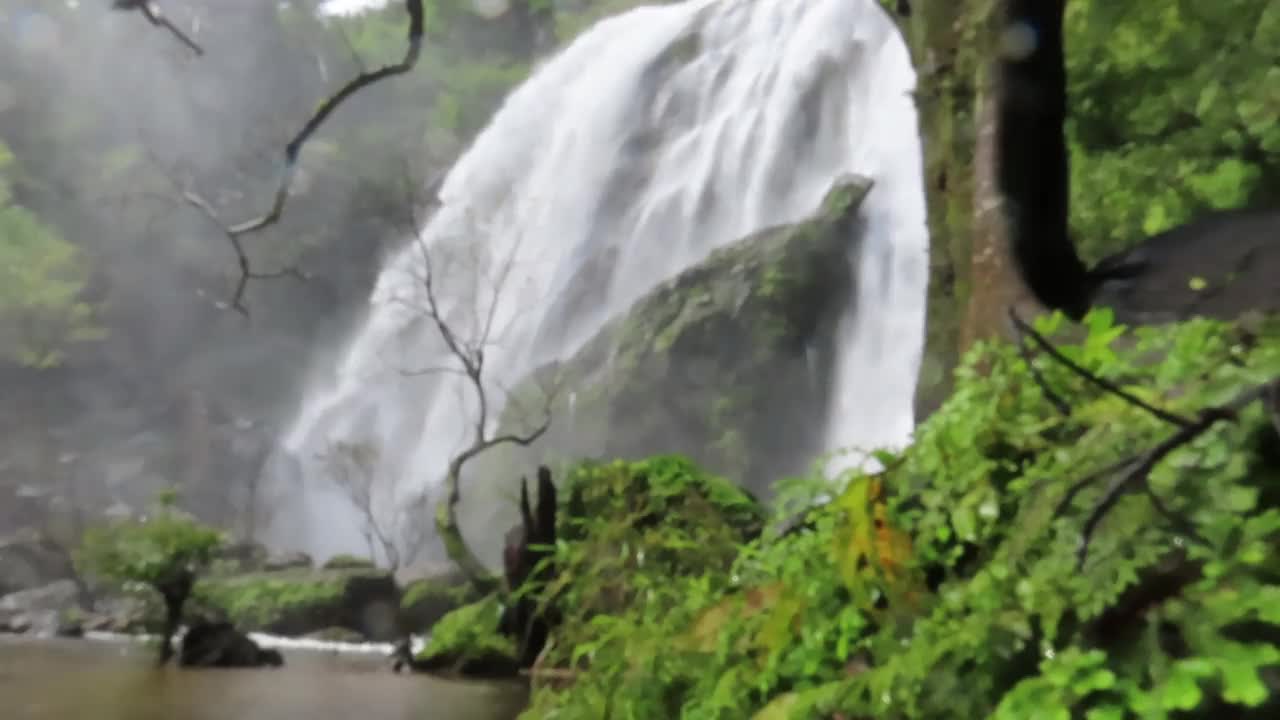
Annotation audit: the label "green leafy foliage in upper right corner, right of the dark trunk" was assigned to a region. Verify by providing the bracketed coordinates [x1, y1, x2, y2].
[1066, 0, 1280, 259]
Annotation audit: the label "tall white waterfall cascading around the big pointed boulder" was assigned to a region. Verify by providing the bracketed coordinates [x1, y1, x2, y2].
[271, 0, 928, 556]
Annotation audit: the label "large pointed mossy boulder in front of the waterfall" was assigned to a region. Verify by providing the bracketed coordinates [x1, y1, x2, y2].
[476, 176, 870, 492]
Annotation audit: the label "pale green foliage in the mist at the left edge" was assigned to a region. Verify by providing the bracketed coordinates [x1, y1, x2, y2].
[0, 142, 101, 369]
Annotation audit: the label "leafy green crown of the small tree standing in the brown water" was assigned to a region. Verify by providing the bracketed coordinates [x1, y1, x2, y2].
[76, 496, 224, 587]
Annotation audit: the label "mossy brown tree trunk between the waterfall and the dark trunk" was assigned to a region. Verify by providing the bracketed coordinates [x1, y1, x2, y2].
[890, 0, 1039, 419]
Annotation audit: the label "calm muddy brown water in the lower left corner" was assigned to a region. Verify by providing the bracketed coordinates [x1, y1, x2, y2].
[0, 637, 526, 720]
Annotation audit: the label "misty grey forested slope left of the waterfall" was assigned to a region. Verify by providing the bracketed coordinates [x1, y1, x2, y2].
[0, 0, 515, 550]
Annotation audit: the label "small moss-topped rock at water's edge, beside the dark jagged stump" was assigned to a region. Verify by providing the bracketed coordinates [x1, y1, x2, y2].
[415, 596, 520, 678]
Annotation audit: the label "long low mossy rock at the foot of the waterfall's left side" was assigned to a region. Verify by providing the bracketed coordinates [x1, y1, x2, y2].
[195, 569, 401, 641]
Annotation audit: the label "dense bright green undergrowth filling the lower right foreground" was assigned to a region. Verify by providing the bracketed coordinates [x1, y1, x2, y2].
[524, 313, 1280, 720]
